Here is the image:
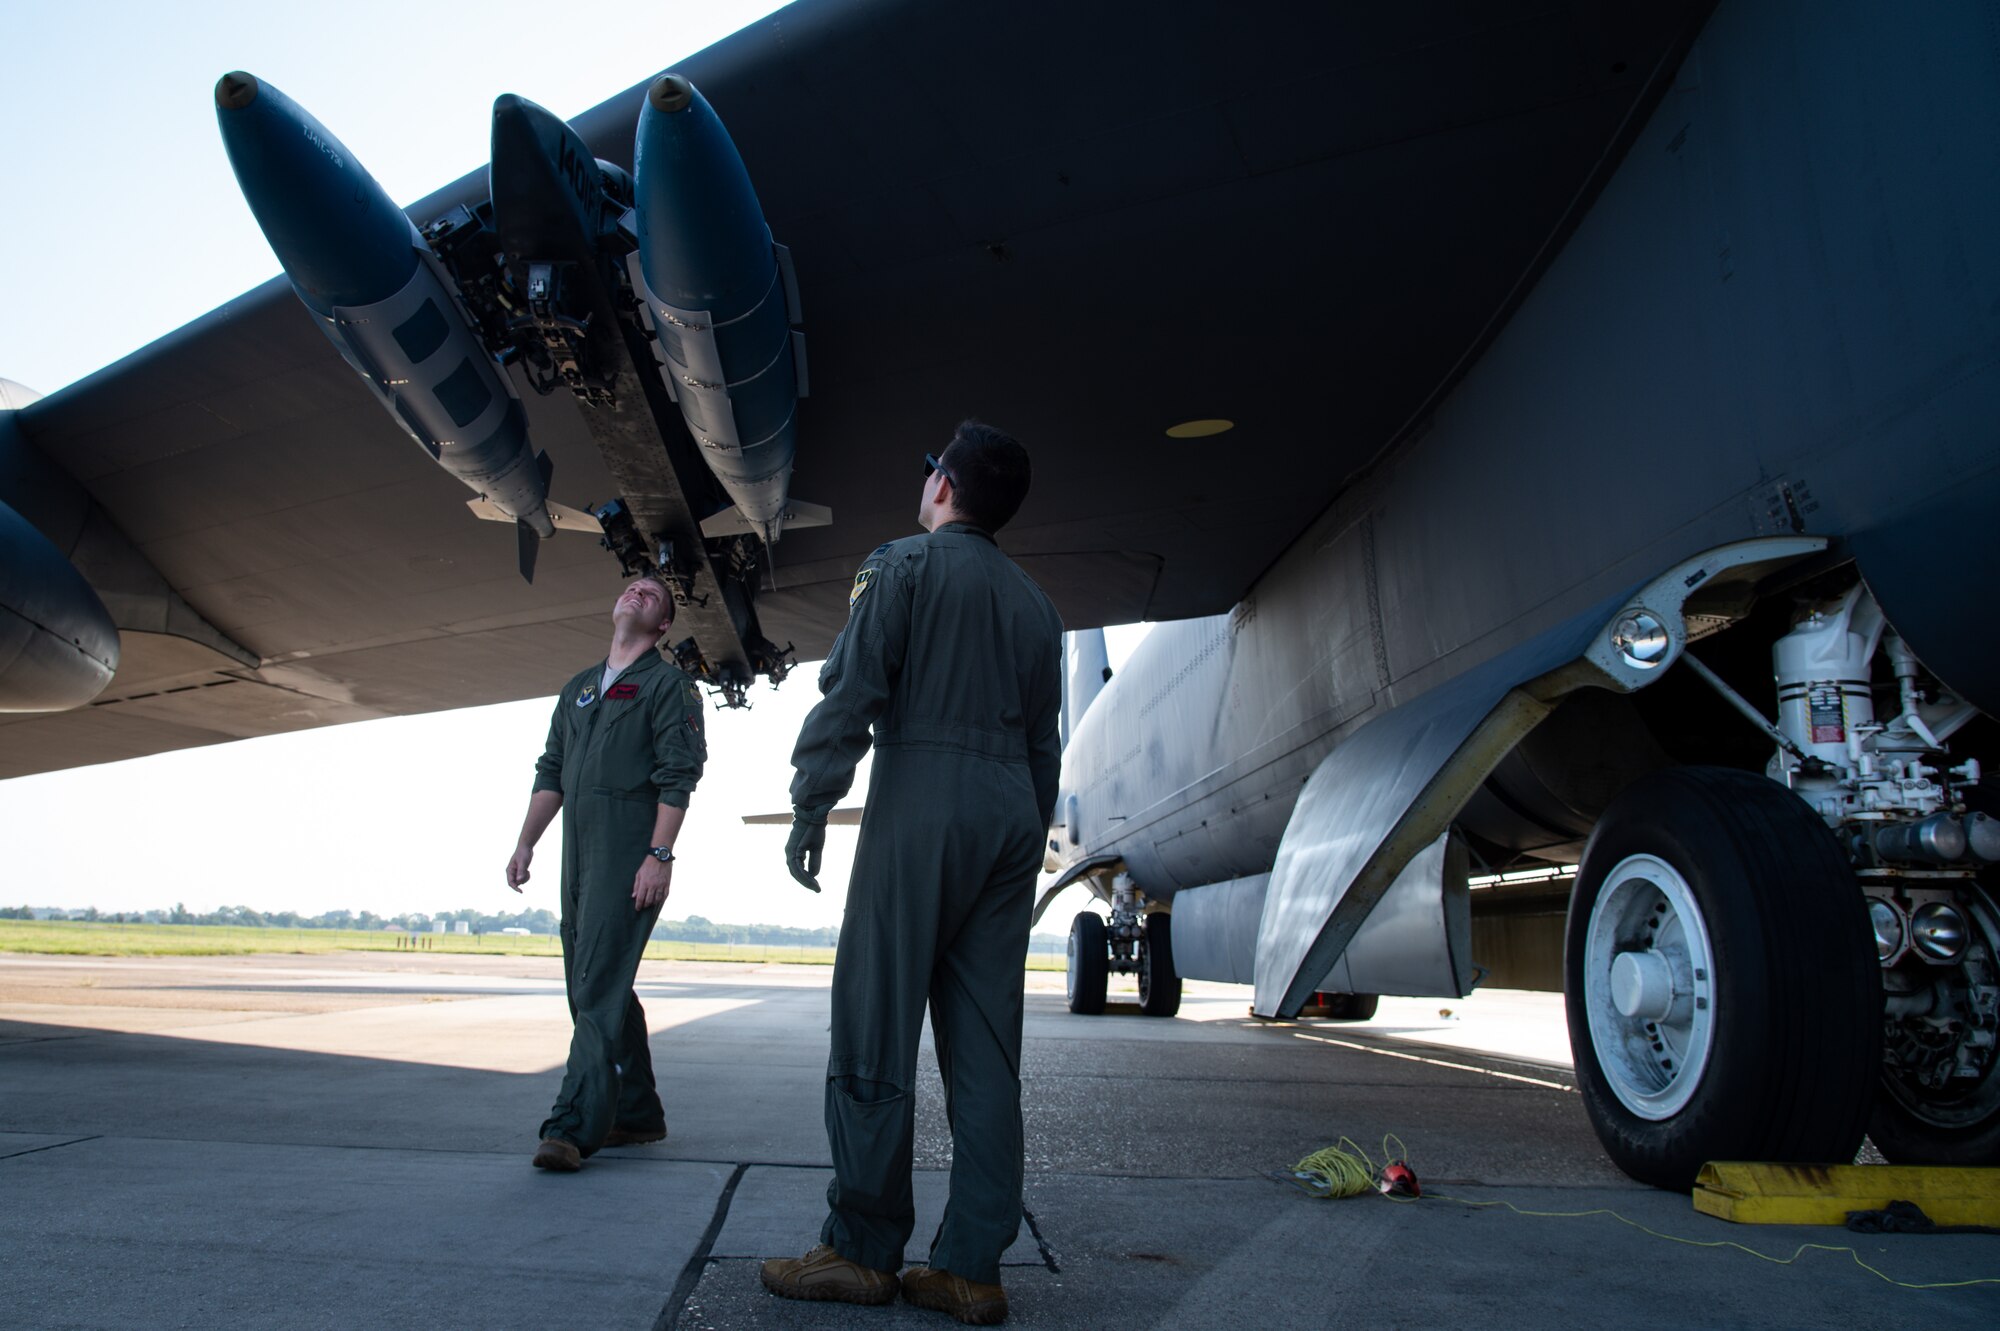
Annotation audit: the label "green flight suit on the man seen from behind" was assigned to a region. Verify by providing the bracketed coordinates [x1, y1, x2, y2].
[792, 524, 1062, 1283]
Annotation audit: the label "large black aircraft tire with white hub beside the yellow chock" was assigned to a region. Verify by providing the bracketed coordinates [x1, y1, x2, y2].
[1564, 767, 1882, 1191]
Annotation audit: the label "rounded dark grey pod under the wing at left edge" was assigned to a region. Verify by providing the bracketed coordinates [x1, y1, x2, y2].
[0, 491, 118, 711]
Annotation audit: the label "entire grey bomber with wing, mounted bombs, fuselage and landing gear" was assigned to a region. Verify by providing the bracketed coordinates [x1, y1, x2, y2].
[0, 0, 2000, 1187]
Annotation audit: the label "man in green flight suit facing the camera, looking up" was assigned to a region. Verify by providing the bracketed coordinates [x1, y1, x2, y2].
[506, 578, 708, 1171]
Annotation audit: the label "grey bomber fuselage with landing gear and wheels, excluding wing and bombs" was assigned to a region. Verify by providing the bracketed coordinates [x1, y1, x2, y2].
[1044, 4, 2000, 1189]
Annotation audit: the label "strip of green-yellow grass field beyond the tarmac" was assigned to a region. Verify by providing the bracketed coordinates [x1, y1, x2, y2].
[0, 919, 1062, 971]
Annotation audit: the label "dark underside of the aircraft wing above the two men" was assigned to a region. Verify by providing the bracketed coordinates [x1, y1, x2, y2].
[0, 0, 1706, 777]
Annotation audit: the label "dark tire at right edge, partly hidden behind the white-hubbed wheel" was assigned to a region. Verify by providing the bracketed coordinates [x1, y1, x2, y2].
[1868, 889, 2000, 1167]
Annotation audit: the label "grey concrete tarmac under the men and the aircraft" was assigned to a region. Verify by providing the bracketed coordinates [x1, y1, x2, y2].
[0, 953, 2000, 1331]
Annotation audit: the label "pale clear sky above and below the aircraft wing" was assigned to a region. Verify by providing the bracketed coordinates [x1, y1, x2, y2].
[0, 0, 1144, 931]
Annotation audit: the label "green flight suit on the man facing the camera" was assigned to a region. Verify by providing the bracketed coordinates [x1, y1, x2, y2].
[534, 652, 708, 1155]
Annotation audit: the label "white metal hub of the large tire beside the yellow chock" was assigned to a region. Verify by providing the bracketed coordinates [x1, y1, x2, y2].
[1584, 855, 1716, 1121]
